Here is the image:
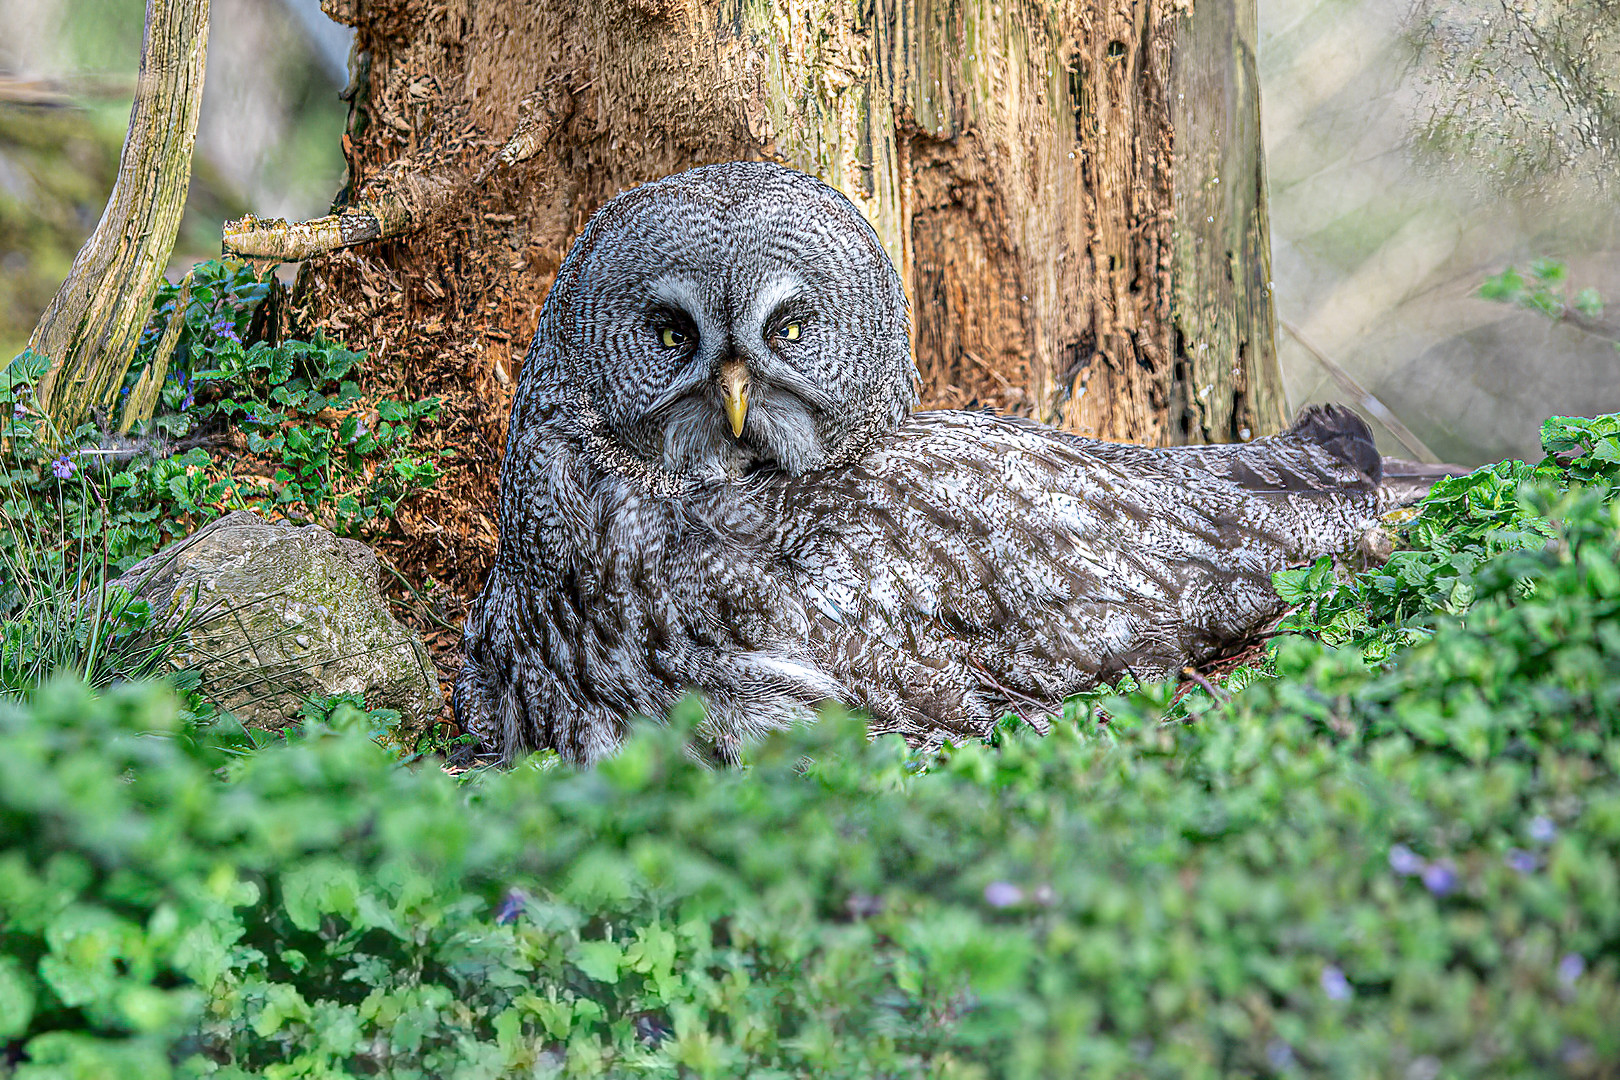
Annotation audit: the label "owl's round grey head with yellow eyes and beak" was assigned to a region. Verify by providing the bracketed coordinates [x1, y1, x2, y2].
[536, 162, 915, 479]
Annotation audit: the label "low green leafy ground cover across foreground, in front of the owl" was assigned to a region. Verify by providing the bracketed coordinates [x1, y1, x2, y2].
[0, 416, 1620, 1080]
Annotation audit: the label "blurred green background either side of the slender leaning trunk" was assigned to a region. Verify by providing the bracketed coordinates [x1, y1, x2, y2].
[0, 0, 347, 356]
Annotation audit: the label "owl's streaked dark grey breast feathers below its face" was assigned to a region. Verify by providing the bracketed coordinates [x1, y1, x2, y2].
[455, 415, 849, 761]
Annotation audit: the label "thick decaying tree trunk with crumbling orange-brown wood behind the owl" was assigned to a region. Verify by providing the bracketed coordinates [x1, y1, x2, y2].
[268, 0, 1281, 595]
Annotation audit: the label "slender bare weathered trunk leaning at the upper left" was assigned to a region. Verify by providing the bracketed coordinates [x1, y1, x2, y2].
[28, 0, 209, 434]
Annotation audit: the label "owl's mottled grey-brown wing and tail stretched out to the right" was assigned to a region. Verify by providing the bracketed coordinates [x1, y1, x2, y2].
[786, 406, 1380, 729]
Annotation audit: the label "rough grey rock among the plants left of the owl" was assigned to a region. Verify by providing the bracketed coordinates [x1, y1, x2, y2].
[118, 510, 442, 730]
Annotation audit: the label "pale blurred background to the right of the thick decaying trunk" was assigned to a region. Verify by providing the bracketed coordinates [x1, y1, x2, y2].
[1260, 0, 1620, 463]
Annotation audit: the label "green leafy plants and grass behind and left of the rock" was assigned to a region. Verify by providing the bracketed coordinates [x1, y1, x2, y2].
[0, 262, 439, 702]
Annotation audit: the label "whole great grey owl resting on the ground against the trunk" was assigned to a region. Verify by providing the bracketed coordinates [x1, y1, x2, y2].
[455, 164, 1380, 761]
